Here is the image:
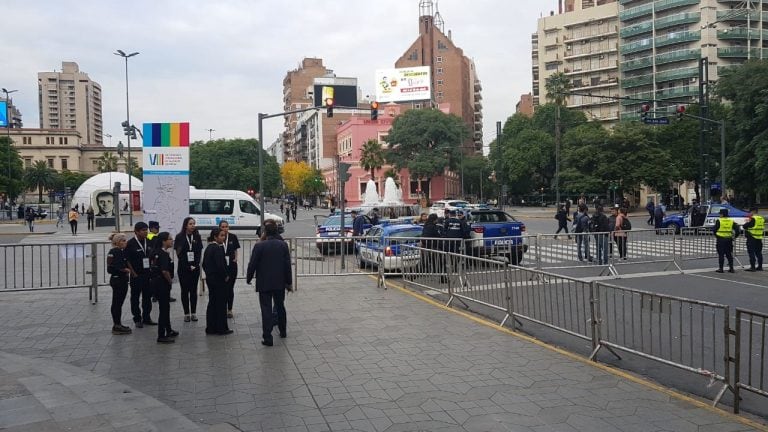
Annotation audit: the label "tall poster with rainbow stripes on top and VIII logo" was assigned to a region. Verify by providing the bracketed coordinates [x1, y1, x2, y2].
[142, 123, 189, 233]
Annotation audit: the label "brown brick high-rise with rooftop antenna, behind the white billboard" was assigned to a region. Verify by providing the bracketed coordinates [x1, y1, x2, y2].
[395, 0, 483, 152]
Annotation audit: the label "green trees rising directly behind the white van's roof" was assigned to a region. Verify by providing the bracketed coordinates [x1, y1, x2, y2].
[189, 138, 280, 196]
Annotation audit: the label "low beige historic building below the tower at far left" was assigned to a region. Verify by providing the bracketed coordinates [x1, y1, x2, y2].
[10, 129, 142, 174]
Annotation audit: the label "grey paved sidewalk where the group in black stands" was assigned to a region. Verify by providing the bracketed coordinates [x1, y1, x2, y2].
[0, 276, 768, 432]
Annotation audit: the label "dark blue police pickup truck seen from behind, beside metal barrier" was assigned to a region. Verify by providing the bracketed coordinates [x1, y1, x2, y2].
[465, 209, 528, 265]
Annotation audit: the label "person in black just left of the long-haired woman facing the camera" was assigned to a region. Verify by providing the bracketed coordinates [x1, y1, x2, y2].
[150, 231, 179, 343]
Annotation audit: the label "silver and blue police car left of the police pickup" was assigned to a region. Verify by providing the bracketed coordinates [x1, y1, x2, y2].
[355, 223, 422, 271]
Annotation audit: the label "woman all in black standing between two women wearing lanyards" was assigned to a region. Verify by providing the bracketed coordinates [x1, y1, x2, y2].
[203, 228, 232, 335]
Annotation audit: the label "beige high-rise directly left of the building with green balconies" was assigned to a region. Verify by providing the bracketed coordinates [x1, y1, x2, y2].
[531, 0, 620, 122]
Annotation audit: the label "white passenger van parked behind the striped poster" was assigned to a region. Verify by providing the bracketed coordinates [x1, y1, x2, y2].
[189, 186, 284, 234]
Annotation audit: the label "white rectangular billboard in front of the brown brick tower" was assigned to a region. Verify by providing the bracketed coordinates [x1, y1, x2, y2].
[376, 66, 432, 102]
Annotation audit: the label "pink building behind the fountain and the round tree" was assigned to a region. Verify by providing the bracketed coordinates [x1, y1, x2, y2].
[323, 104, 461, 206]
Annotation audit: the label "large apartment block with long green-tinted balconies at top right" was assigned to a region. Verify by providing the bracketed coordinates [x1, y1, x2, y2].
[619, 0, 768, 120]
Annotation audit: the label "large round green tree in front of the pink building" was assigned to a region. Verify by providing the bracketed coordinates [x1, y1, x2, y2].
[385, 109, 469, 179]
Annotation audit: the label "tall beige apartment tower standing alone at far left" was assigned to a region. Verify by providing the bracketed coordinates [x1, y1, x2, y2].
[37, 62, 103, 145]
